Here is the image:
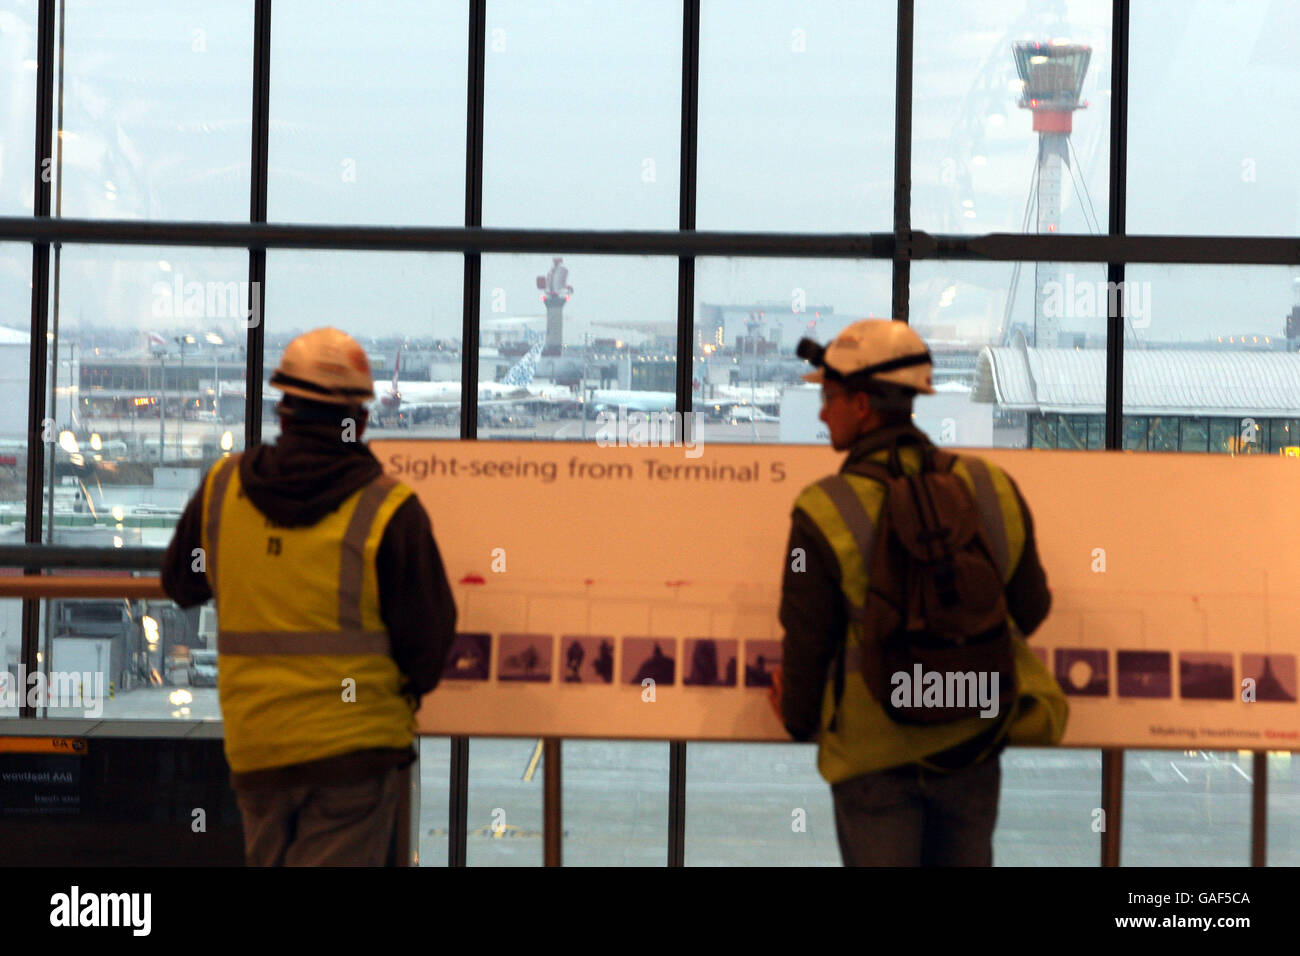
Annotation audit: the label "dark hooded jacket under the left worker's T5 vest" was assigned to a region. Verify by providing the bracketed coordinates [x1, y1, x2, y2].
[163, 424, 456, 790]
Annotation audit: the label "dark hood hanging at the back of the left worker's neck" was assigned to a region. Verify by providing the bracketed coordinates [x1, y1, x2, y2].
[239, 425, 384, 528]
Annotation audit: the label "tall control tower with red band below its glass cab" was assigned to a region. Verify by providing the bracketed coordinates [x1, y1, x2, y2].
[1013, 40, 1092, 349]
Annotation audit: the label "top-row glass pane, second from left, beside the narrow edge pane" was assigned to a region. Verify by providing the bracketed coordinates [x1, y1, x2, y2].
[53, 0, 254, 220]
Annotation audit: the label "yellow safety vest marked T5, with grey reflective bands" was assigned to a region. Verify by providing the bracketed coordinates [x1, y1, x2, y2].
[203, 455, 413, 774]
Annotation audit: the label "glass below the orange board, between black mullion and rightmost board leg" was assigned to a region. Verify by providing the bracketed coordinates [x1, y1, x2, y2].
[1119, 750, 1252, 866]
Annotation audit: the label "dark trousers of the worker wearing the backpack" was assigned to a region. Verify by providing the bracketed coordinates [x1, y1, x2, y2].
[831, 756, 1002, 866]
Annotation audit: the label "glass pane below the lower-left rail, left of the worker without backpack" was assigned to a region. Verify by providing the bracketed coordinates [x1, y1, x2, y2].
[31, 595, 221, 721]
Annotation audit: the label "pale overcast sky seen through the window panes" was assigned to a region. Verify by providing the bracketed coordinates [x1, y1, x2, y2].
[0, 0, 1300, 342]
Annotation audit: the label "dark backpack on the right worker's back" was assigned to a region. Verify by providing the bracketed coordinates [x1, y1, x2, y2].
[849, 444, 1017, 730]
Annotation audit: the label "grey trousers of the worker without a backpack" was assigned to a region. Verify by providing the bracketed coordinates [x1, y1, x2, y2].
[235, 770, 403, 866]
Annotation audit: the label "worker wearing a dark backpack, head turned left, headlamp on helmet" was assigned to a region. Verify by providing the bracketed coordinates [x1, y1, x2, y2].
[770, 319, 1066, 866]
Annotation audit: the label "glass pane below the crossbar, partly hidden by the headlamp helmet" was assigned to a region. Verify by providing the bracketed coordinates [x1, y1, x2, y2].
[692, 259, 892, 444]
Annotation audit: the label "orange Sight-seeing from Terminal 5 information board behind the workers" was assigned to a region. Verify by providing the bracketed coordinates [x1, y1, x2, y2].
[371, 441, 1300, 749]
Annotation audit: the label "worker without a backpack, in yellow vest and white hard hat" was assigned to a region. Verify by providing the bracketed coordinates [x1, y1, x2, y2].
[163, 329, 456, 866]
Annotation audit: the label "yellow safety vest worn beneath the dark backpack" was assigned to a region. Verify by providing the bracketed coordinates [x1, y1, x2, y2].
[794, 445, 1067, 783]
